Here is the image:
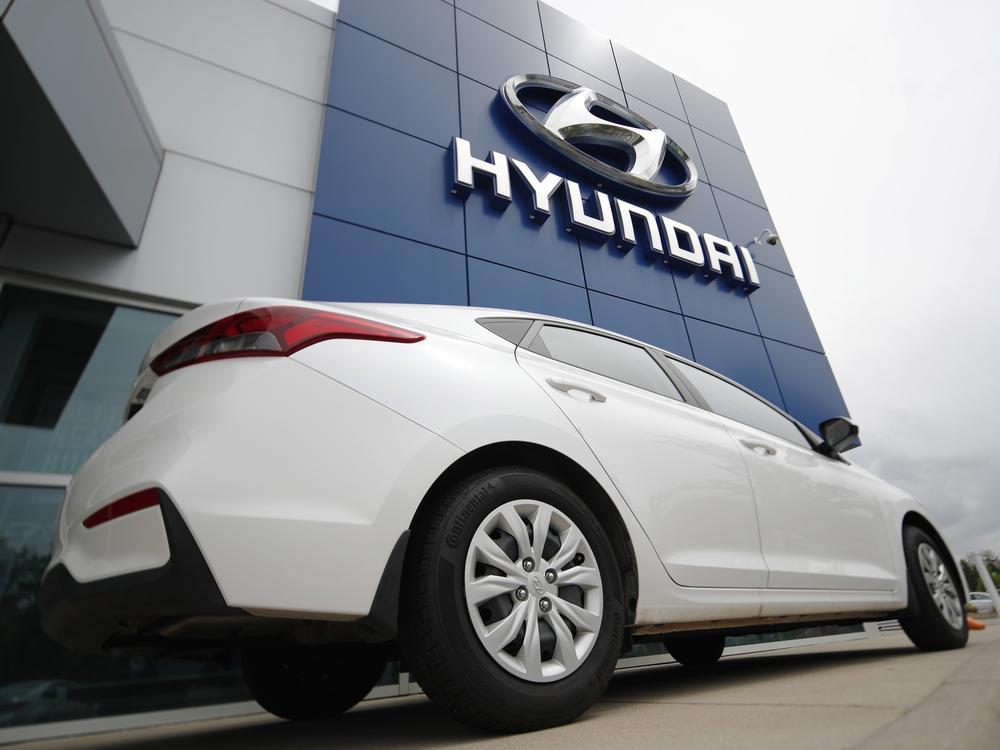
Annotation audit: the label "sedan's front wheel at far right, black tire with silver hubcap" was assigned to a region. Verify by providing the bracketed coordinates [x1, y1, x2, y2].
[899, 526, 969, 651]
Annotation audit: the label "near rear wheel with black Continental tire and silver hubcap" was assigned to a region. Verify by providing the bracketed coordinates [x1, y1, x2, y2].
[400, 466, 624, 732]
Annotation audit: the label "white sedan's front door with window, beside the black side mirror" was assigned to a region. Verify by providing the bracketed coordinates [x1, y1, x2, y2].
[671, 360, 897, 591]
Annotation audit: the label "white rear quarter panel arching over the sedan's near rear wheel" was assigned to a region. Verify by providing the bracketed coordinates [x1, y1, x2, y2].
[293, 334, 760, 624]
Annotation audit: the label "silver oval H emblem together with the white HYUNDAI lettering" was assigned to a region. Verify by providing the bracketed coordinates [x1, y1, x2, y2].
[451, 74, 760, 292]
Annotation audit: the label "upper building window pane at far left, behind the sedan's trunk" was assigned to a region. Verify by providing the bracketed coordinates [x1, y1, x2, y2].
[0, 284, 175, 474]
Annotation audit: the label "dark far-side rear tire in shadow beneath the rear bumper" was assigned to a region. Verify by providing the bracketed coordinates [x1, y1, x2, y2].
[242, 644, 386, 721]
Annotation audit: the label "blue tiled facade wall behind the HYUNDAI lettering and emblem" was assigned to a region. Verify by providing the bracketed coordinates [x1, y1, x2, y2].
[302, 0, 846, 428]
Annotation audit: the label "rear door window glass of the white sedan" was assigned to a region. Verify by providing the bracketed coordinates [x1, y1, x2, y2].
[528, 326, 683, 401]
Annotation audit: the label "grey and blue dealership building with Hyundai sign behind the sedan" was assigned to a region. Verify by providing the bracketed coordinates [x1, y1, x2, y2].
[0, 0, 847, 742]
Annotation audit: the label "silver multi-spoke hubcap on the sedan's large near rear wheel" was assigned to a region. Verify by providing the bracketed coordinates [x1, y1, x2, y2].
[465, 499, 604, 682]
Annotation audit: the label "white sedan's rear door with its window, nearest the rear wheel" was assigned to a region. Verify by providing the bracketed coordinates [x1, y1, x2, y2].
[517, 324, 767, 588]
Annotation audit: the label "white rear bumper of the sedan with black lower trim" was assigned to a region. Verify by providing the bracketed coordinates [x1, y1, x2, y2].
[39, 358, 462, 648]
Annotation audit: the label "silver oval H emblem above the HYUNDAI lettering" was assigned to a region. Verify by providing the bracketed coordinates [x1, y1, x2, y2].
[500, 73, 698, 198]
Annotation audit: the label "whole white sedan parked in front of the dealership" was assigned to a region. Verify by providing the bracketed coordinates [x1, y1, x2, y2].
[42, 299, 968, 731]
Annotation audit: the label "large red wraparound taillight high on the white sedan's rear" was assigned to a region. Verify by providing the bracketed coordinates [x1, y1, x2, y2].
[150, 307, 424, 375]
